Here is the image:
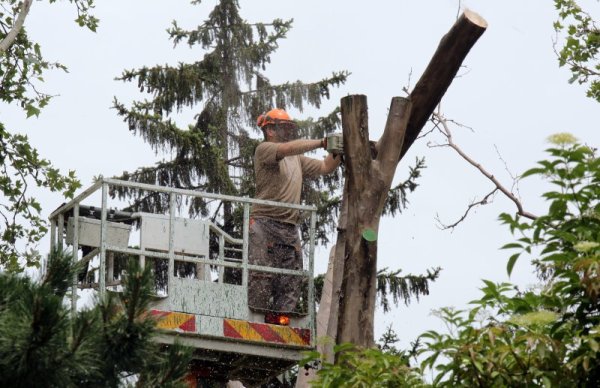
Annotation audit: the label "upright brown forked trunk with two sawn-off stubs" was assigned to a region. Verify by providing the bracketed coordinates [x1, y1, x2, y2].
[336, 95, 411, 347]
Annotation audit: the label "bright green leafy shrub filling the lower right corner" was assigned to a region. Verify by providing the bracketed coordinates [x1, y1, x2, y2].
[420, 134, 600, 387]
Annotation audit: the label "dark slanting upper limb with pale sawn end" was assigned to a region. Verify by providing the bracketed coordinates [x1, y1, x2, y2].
[400, 10, 487, 158]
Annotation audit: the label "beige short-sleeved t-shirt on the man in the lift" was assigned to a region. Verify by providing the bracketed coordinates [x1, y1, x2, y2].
[252, 141, 322, 224]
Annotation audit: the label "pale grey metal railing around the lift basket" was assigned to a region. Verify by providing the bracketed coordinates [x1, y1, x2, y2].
[49, 177, 317, 335]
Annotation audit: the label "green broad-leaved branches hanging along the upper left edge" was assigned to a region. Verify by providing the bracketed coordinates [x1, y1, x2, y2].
[0, 0, 98, 272]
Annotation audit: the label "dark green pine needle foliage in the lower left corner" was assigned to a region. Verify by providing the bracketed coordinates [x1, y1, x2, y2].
[0, 250, 191, 387]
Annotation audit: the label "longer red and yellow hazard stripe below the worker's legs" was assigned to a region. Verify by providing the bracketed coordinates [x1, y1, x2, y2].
[223, 319, 310, 346]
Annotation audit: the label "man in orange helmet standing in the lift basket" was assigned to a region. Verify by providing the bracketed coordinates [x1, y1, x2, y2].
[248, 109, 341, 314]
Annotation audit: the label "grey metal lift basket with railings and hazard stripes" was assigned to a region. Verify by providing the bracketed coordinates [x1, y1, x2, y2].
[50, 178, 316, 385]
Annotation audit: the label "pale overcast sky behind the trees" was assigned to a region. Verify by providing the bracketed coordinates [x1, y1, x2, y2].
[0, 0, 600, 346]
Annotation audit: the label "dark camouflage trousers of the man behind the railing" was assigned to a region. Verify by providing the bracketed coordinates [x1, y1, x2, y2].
[248, 218, 302, 313]
